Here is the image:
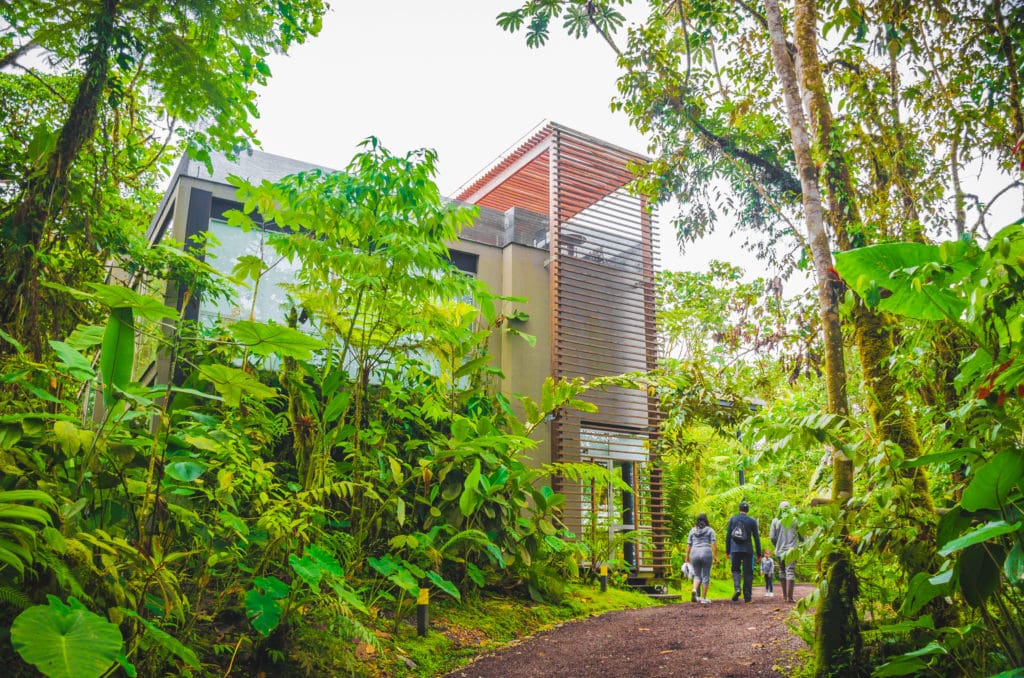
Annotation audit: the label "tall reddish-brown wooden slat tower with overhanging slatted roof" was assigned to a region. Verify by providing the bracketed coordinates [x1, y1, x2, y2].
[459, 124, 669, 575]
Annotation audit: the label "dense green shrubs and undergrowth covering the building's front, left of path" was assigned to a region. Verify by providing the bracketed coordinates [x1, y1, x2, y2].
[0, 140, 618, 675]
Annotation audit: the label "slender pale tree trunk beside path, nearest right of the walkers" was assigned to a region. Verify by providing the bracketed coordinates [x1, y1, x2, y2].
[765, 0, 862, 676]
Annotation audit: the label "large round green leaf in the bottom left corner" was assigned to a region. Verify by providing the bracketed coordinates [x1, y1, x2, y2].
[10, 596, 124, 678]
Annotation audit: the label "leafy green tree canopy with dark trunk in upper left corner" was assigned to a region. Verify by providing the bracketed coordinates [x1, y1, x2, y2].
[0, 0, 326, 358]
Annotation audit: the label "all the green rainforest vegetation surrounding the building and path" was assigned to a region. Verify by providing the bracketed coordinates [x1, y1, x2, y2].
[0, 0, 1024, 676]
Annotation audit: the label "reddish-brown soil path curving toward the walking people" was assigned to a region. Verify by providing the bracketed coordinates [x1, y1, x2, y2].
[449, 585, 812, 678]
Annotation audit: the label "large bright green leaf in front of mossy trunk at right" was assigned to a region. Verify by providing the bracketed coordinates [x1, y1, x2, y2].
[836, 243, 968, 320]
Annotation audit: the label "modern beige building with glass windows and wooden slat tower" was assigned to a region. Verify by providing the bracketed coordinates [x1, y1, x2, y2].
[150, 123, 669, 576]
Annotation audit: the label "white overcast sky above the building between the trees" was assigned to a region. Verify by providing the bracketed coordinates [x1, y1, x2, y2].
[249, 0, 758, 276]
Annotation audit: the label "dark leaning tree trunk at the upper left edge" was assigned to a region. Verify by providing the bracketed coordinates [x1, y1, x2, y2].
[0, 0, 119, 356]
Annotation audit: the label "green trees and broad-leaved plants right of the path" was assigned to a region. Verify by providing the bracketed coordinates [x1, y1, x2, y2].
[498, 0, 1024, 676]
